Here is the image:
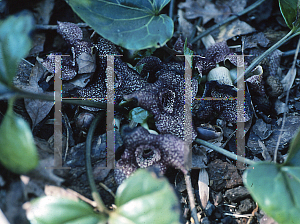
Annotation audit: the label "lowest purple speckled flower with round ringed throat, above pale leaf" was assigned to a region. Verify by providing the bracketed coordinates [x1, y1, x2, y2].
[114, 127, 186, 184]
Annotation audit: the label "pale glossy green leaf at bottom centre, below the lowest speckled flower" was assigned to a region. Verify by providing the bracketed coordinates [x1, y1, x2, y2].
[109, 169, 180, 224]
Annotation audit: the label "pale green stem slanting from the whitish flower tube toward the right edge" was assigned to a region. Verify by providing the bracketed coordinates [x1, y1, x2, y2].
[240, 30, 298, 82]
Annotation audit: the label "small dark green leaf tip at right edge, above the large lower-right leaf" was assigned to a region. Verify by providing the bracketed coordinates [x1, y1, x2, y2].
[285, 129, 300, 167]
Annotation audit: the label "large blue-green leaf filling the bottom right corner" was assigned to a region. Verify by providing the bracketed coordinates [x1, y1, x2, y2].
[243, 162, 300, 224]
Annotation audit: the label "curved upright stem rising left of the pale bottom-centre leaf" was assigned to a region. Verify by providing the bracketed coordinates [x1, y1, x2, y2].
[85, 113, 108, 213]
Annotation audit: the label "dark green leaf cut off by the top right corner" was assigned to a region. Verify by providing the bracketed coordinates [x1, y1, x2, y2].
[279, 0, 299, 30]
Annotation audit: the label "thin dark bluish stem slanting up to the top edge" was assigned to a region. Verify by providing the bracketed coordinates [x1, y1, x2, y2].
[191, 0, 265, 44]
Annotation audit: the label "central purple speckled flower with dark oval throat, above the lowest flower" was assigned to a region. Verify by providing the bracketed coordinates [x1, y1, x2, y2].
[124, 65, 198, 139]
